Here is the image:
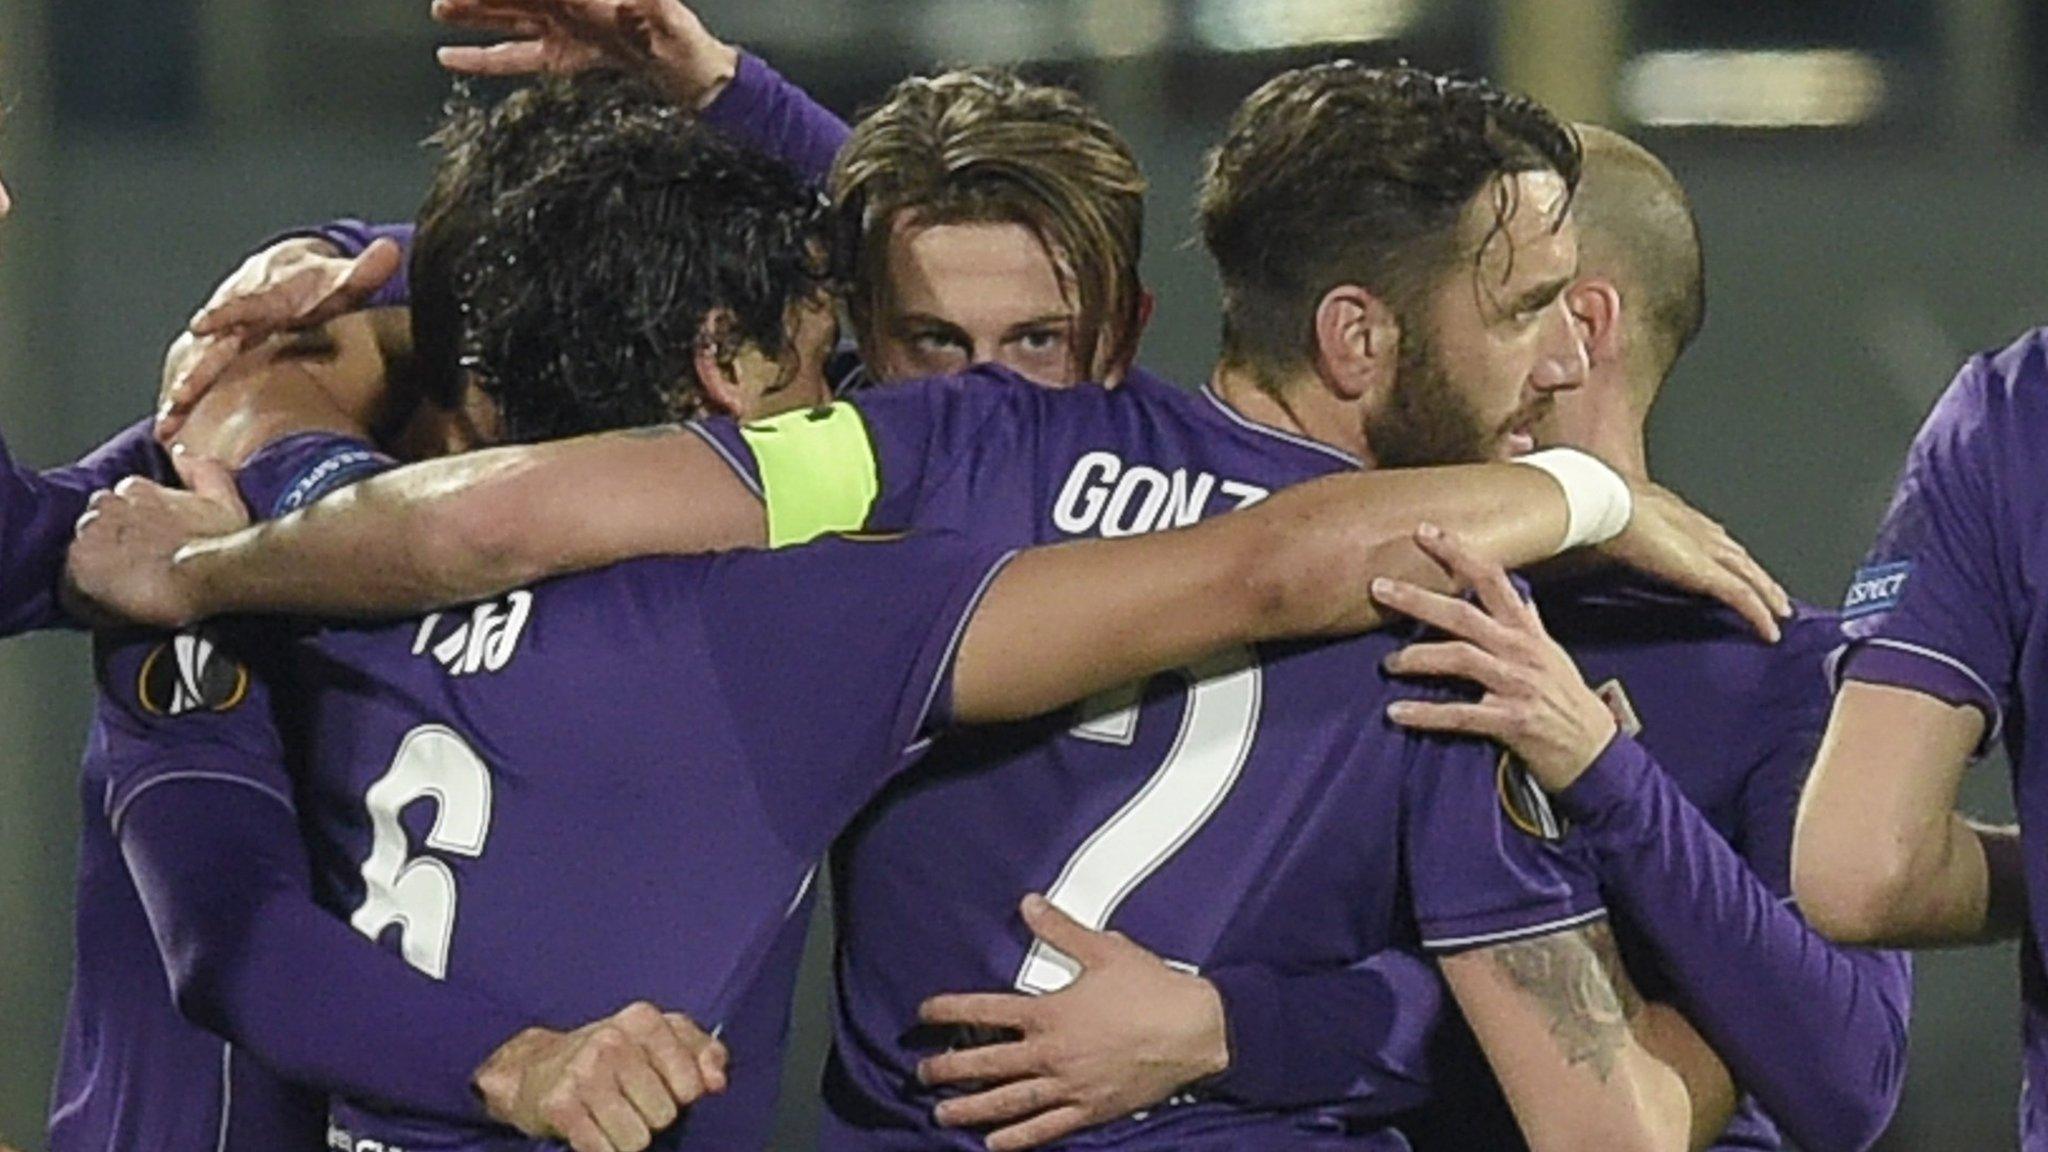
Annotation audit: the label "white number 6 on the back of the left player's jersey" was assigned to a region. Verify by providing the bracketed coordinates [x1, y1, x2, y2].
[348, 724, 492, 980]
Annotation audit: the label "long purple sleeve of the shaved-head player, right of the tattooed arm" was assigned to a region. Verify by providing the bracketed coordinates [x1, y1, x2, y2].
[1556, 736, 1911, 1152]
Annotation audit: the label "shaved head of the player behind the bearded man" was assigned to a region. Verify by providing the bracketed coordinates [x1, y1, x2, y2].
[1573, 125, 1706, 393]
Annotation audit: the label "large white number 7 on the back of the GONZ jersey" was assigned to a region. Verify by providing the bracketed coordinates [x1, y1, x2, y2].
[1016, 650, 1262, 992]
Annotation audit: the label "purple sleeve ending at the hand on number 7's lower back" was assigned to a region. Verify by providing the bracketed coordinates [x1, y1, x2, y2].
[1202, 949, 1446, 1115]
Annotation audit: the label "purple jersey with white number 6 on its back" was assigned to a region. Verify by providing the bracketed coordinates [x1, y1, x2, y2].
[161, 437, 1015, 1150]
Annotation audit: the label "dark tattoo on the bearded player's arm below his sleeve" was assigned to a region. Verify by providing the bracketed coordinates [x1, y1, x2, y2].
[1491, 924, 1642, 1082]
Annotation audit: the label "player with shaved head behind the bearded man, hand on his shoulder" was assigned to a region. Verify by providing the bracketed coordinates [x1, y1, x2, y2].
[1335, 125, 1911, 1150]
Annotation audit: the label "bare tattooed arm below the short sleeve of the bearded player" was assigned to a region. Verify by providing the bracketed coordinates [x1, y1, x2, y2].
[1442, 922, 1735, 1152]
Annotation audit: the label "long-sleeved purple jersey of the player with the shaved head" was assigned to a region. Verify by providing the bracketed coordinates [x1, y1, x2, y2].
[1409, 572, 1911, 1150]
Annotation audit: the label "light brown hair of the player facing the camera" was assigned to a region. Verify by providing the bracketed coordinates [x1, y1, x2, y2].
[831, 68, 1145, 375]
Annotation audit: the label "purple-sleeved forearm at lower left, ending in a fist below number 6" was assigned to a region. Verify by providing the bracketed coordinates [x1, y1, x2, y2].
[121, 781, 530, 1121]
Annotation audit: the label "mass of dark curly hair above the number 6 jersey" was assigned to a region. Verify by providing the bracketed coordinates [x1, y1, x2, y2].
[412, 74, 838, 441]
